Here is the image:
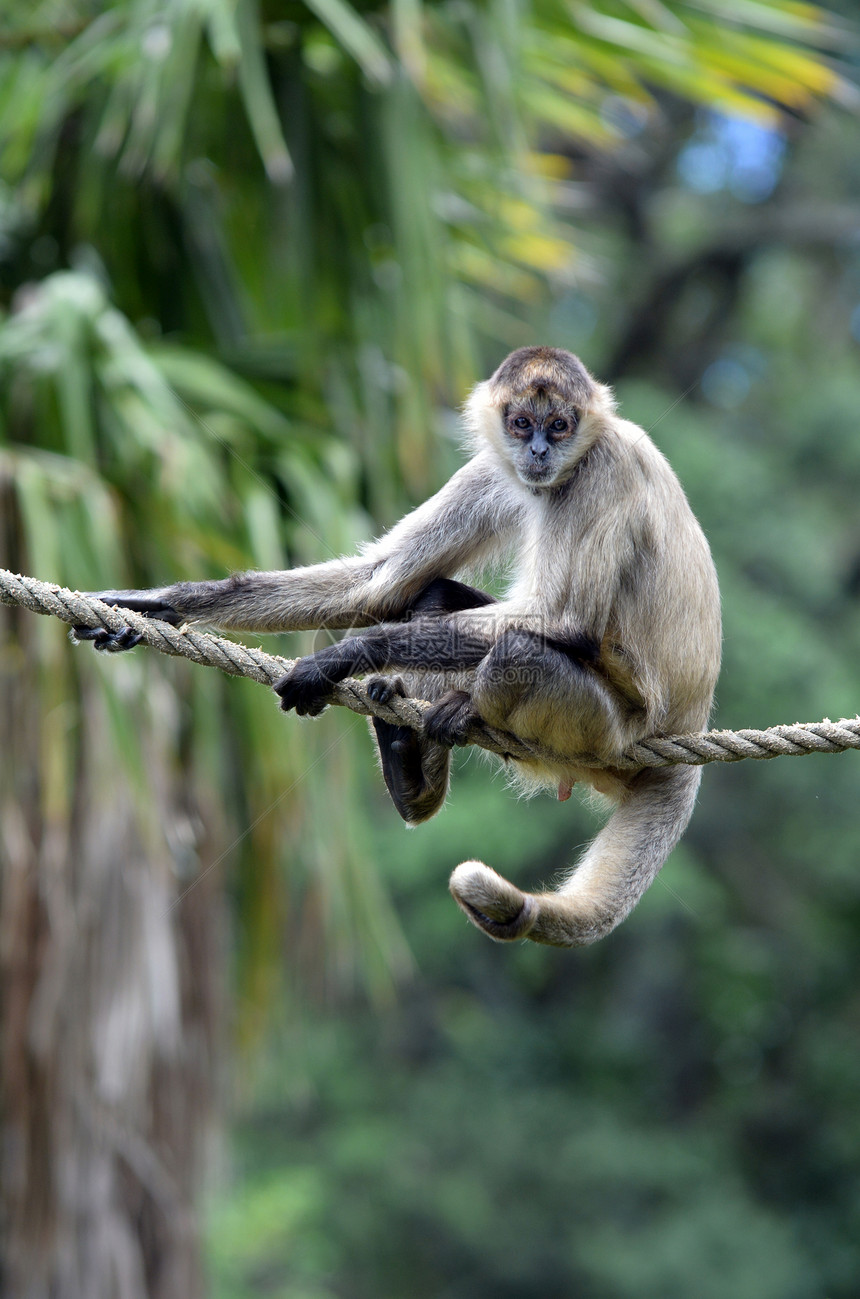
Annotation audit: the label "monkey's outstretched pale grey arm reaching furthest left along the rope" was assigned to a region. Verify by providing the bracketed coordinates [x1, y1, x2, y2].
[77, 455, 521, 650]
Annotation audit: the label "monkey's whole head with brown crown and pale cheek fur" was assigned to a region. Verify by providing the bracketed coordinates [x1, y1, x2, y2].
[465, 347, 613, 488]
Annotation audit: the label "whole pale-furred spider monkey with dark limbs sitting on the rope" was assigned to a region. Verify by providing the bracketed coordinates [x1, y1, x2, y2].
[78, 347, 721, 946]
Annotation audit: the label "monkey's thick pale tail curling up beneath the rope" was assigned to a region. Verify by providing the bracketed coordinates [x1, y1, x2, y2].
[449, 766, 702, 947]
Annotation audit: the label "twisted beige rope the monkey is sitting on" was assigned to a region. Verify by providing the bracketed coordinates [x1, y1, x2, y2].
[0, 569, 860, 770]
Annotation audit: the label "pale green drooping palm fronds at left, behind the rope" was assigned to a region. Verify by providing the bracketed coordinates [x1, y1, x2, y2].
[0, 271, 409, 1002]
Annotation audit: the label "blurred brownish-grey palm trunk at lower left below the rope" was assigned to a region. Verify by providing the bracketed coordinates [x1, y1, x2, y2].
[0, 592, 223, 1299]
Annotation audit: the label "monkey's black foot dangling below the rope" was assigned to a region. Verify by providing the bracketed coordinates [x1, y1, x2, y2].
[368, 677, 451, 825]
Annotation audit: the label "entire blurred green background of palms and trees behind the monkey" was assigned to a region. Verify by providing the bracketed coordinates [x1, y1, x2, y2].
[0, 0, 860, 1299]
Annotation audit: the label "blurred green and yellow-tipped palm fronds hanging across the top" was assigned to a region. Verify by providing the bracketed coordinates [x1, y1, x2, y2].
[0, 0, 846, 491]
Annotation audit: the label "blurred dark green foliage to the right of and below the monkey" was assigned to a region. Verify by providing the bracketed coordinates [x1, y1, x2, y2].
[213, 71, 860, 1299]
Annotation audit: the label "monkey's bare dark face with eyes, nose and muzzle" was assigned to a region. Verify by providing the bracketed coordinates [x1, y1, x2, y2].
[501, 387, 582, 487]
